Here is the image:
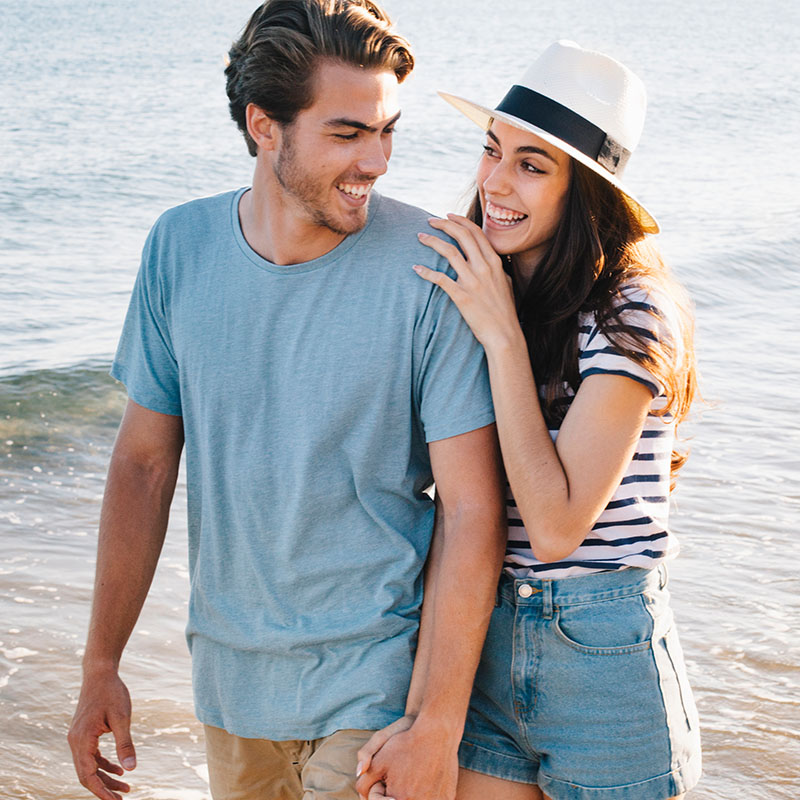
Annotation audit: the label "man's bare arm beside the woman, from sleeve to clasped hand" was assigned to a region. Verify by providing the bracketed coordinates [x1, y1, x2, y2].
[357, 425, 507, 800]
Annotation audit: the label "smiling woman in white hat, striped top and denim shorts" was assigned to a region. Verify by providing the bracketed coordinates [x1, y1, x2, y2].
[358, 42, 700, 800]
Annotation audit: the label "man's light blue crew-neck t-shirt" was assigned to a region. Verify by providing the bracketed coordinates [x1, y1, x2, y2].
[112, 189, 494, 739]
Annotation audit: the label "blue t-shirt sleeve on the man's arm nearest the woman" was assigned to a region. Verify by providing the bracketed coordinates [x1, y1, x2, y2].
[417, 269, 494, 442]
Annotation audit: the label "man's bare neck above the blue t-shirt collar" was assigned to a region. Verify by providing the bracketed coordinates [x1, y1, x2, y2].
[239, 165, 345, 266]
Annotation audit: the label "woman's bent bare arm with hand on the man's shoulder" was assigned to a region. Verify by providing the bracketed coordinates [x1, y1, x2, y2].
[415, 215, 652, 562]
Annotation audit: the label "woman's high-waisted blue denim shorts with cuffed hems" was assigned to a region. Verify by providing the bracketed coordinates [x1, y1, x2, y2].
[459, 566, 701, 800]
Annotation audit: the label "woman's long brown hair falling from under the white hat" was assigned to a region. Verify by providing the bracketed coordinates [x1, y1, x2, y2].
[467, 159, 697, 488]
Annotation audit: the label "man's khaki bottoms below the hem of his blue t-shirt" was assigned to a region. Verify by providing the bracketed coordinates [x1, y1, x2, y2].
[204, 725, 373, 800]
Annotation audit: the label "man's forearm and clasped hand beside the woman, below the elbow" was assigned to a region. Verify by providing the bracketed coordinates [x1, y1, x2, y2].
[357, 506, 506, 800]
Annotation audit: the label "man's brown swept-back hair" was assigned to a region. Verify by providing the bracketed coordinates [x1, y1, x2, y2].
[225, 0, 414, 156]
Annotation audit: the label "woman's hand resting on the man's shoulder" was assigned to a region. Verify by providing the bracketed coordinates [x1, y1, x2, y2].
[414, 214, 521, 349]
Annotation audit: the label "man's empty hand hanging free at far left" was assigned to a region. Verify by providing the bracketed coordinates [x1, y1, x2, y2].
[67, 669, 136, 800]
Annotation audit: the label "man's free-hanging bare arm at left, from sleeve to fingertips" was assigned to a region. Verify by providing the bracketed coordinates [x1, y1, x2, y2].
[69, 400, 183, 800]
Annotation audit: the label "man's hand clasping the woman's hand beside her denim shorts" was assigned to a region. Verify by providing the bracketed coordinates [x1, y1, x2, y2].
[356, 717, 460, 800]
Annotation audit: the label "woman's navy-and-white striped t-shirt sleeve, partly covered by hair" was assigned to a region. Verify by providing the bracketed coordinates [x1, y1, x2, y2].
[578, 288, 680, 398]
